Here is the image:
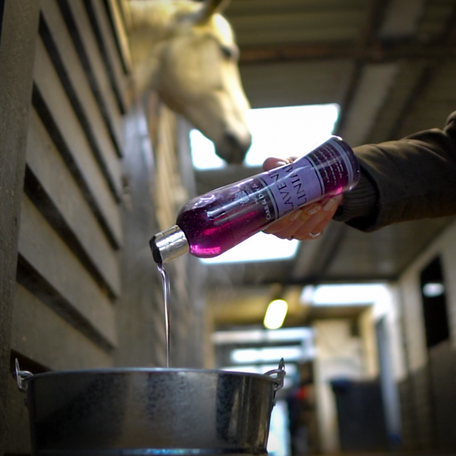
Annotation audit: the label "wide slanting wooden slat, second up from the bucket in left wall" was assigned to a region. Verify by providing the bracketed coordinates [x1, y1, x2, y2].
[18, 195, 117, 347]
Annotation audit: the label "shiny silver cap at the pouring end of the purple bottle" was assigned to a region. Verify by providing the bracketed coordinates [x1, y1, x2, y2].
[149, 225, 190, 264]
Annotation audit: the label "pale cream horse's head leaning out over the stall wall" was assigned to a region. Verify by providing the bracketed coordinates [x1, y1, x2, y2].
[128, 0, 252, 163]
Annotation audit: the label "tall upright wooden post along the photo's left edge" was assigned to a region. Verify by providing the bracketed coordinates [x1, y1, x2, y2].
[0, 0, 39, 454]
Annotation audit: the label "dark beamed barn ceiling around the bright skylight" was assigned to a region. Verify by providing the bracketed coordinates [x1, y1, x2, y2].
[197, 0, 456, 327]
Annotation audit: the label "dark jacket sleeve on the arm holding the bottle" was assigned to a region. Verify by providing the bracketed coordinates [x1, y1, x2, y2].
[334, 111, 456, 231]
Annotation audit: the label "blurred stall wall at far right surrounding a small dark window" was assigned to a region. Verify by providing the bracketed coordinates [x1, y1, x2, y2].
[398, 219, 456, 451]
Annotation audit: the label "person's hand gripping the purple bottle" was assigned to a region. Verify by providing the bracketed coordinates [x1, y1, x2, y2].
[263, 157, 343, 241]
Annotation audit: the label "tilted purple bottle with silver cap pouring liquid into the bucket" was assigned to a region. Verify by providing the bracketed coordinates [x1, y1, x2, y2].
[150, 136, 360, 264]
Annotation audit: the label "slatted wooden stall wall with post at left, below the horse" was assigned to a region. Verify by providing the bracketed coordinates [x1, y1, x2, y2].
[0, 0, 206, 454]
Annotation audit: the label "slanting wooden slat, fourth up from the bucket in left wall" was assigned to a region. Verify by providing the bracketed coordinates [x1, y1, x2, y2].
[34, 39, 122, 246]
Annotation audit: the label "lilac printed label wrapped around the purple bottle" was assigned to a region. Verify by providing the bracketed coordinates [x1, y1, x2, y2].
[260, 138, 353, 218]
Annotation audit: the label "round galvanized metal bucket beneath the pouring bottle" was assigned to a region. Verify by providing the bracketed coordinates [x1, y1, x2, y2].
[16, 360, 285, 456]
